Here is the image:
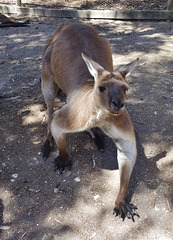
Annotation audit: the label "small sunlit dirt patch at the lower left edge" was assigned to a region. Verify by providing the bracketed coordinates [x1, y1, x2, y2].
[0, 187, 15, 224]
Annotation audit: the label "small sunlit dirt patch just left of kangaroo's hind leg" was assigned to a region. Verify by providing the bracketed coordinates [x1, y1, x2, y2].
[19, 104, 45, 126]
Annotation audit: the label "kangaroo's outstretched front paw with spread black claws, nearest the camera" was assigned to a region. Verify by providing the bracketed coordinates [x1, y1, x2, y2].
[113, 201, 139, 222]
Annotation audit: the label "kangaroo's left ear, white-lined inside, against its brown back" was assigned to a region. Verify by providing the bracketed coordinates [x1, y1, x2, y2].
[81, 53, 104, 80]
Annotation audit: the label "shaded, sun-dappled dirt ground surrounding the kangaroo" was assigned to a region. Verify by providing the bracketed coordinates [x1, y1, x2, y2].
[0, 15, 173, 240]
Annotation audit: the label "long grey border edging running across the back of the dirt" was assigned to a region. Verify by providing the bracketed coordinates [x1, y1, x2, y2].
[0, 6, 173, 20]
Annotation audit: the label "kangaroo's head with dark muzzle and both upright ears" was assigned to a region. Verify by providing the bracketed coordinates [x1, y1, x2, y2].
[82, 54, 139, 114]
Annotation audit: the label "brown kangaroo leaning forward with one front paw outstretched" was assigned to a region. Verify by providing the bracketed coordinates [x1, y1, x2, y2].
[42, 23, 139, 221]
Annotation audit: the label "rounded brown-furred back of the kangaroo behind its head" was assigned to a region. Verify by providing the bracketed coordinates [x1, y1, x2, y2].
[44, 23, 113, 95]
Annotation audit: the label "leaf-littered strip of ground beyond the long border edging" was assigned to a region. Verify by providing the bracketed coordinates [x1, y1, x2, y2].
[0, 0, 168, 10]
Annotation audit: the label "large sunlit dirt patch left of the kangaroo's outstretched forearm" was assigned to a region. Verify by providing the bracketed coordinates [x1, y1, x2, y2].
[39, 169, 119, 228]
